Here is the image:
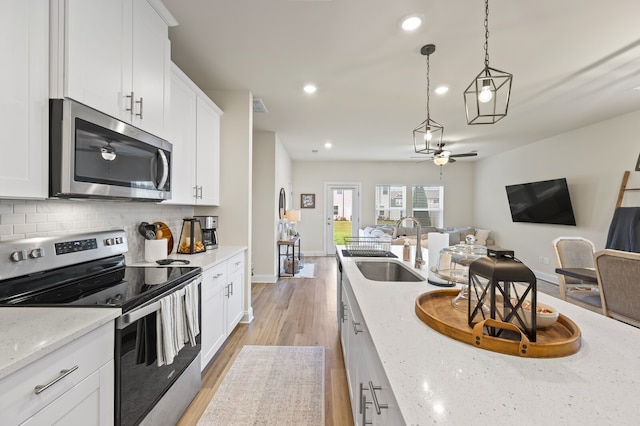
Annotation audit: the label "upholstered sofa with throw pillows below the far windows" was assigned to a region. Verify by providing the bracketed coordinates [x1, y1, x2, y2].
[358, 225, 495, 248]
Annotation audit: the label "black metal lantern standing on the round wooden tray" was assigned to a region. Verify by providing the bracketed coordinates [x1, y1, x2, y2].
[468, 249, 537, 342]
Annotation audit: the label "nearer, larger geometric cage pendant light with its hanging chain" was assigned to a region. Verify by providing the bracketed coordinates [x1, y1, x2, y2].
[464, 0, 513, 124]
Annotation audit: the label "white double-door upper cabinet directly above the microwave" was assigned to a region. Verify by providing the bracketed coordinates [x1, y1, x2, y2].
[51, 0, 173, 137]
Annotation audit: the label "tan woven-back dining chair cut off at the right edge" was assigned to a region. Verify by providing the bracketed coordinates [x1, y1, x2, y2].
[594, 249, 640, 327]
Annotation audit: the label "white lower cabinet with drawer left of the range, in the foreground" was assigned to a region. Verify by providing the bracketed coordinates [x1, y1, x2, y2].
[0, 322, 115, 426]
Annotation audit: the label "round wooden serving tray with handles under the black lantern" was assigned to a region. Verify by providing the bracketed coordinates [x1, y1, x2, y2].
[415, 289, 581, 358]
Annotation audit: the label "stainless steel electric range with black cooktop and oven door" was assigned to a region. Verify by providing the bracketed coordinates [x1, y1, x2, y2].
[0, 230, 202, 426]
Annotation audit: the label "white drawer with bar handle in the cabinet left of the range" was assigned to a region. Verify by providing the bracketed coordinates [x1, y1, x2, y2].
[0, 322, 115, 424]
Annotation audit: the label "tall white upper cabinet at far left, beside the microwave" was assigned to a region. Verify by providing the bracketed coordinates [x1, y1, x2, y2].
[0, 0, 49, 198]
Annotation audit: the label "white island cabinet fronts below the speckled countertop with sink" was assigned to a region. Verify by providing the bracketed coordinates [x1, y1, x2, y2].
[339, 276, 405, 426]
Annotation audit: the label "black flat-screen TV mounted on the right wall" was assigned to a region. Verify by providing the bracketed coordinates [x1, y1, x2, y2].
[507, 178, 576, 226]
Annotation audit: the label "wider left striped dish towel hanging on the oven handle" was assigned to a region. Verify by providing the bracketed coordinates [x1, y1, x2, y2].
[156, 291, 185, 367]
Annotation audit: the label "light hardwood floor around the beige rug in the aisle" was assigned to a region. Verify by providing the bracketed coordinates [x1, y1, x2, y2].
[178, 256, 353, 426]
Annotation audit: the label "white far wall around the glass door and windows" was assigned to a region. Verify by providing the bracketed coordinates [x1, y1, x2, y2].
[293, 161, 477, 256]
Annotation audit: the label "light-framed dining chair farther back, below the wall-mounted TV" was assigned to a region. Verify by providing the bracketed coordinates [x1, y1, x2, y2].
[552, 236, 604, 313]
